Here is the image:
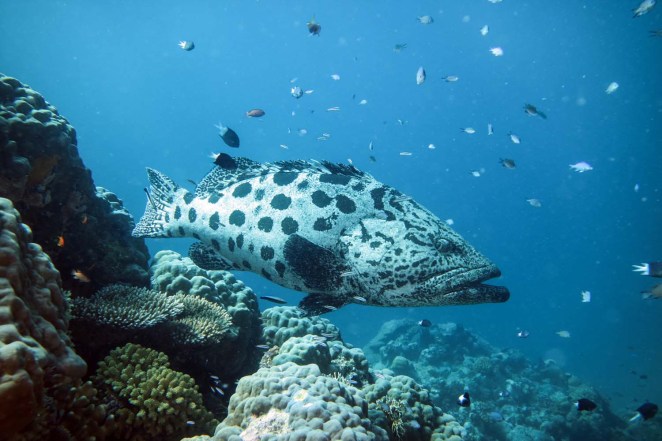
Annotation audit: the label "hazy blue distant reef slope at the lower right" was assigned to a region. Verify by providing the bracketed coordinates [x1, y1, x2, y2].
[364, 320, 628, 441]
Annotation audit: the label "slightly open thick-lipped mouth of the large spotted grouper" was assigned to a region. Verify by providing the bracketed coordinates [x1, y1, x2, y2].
[434, 264, 510, 305]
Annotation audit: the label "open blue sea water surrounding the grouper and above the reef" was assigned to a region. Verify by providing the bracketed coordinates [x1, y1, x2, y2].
[0, 0, 662, 416]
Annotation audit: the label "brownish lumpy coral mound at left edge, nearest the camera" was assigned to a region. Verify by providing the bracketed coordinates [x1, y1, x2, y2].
[0, 198, 87, 438]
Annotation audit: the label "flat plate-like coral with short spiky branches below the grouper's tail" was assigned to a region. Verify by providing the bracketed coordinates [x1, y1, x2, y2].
[71, 284, 184, 330]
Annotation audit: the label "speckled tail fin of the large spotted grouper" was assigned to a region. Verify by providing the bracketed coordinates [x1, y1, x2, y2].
[131, 167, 180, 237]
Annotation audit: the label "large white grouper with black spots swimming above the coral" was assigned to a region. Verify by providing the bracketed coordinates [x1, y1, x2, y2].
[133, 154, 510, 314]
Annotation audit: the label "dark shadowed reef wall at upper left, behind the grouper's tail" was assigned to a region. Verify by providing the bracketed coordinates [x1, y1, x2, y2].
[0, 74, 149, 293]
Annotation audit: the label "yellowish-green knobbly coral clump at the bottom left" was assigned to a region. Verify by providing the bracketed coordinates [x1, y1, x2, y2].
[92, 343, 216, 441]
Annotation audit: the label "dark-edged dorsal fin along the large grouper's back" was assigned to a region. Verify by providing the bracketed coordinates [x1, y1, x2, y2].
[195, 153, 370, 197]
